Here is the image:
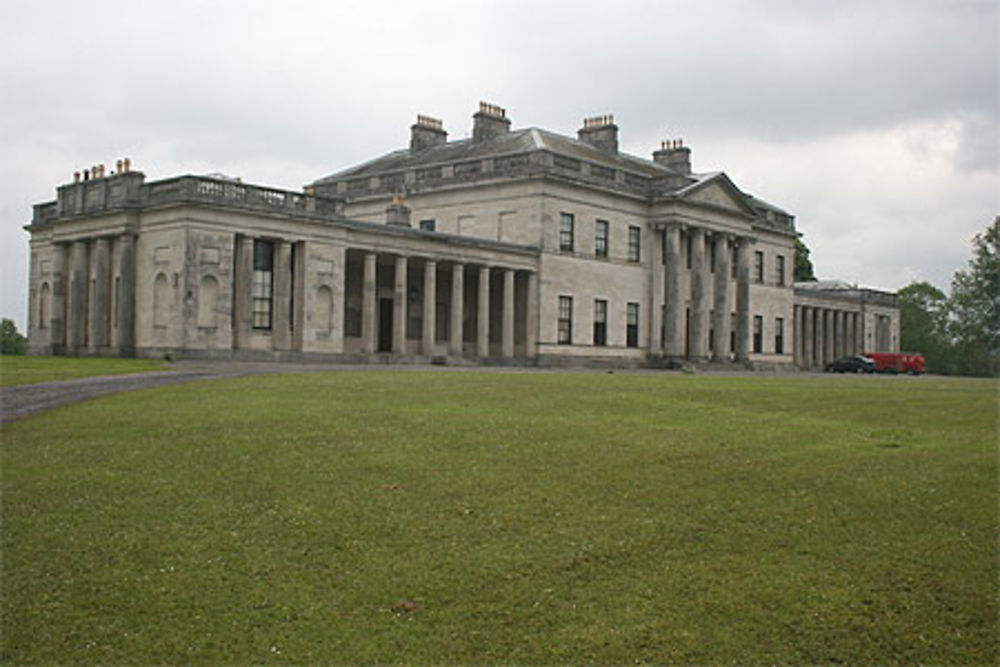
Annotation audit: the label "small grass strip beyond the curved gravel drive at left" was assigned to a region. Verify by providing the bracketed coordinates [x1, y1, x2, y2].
[0, 355, 165, 387]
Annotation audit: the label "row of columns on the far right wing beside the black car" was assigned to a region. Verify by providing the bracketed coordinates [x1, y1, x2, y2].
[795, 304, 864, 368]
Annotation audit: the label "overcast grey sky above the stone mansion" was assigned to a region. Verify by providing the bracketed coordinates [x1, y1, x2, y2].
[0, 0, 1000, 331]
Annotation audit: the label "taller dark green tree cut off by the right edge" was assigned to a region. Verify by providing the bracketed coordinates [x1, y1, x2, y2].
[948, 216, 1000, 376]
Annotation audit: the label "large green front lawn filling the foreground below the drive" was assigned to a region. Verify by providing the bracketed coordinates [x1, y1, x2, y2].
[0, 371, 998, 664]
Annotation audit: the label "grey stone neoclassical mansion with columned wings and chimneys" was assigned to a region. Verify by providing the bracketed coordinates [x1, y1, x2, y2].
[26, 104, 898, 368]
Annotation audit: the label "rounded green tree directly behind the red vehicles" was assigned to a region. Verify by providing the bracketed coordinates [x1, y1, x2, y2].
[897, 282, 955, 373]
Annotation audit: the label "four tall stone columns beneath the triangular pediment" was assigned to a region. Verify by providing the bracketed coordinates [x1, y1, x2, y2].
[650, 223, 754, 361]
